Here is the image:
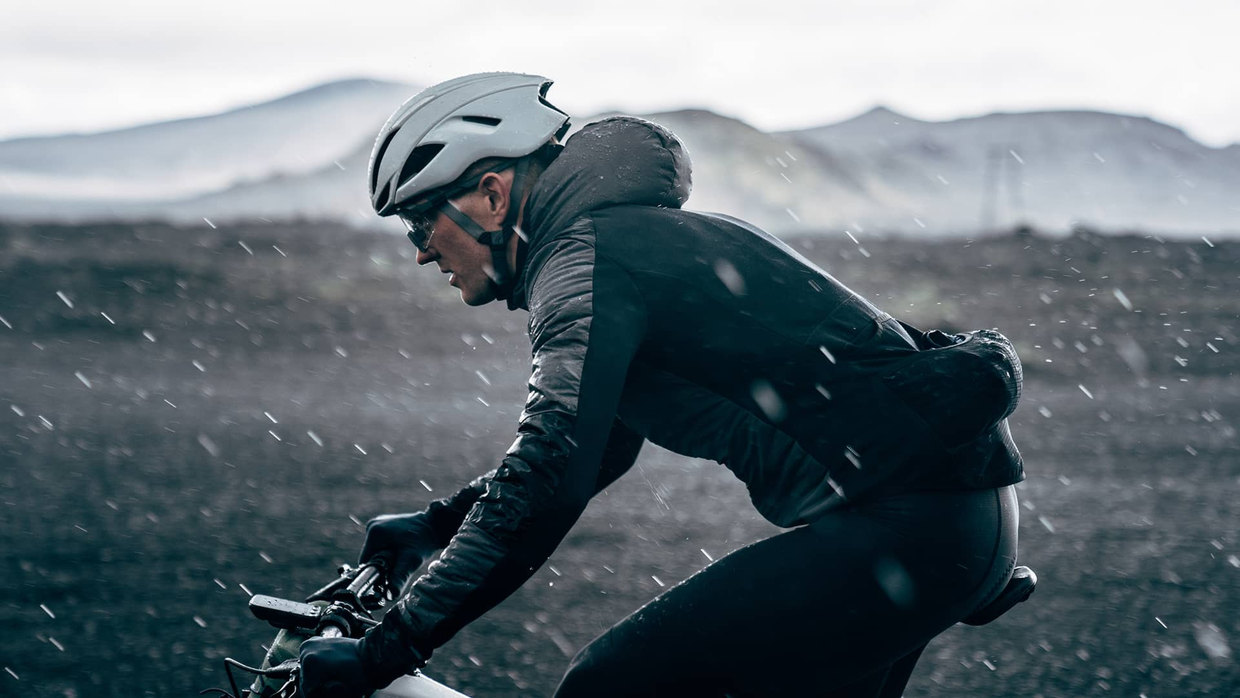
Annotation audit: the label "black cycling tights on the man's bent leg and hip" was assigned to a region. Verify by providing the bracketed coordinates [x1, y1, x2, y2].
[556, 486, 1018, 698]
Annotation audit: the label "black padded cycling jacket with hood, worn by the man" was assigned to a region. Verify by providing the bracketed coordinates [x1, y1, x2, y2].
[363, 117, 1023, 672]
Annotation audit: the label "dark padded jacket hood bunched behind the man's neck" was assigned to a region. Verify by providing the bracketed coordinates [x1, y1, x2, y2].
[508, 117, 692, 307]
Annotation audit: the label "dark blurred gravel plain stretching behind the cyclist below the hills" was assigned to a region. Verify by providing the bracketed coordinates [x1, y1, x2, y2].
[0, 222, 1240, 698]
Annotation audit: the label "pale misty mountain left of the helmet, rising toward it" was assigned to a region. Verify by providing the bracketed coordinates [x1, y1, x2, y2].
[0, 79, 417, 208]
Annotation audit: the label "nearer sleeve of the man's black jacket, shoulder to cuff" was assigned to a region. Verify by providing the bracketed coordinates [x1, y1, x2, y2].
[362, 236, 646, 682]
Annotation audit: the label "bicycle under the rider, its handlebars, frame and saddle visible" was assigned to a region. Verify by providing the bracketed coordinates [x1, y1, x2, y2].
[201, 560, 1038, 698]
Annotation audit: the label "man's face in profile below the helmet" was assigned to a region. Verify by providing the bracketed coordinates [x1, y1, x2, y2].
[418, 191, 496, 305]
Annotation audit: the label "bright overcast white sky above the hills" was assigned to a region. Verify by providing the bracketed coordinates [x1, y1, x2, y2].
[0, 0, 1240, 146]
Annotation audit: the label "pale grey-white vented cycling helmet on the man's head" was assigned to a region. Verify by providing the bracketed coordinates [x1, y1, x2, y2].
[368, 73, 569, 216]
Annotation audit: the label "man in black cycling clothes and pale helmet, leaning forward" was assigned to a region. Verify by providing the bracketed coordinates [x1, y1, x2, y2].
[301, 73, 1023, 698]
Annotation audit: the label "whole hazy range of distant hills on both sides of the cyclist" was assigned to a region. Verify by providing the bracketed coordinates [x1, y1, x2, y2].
[0, 79, 1240, 237]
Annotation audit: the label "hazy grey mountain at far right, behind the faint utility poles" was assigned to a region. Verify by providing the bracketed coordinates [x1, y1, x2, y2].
[784, 108, 1240, 233]
